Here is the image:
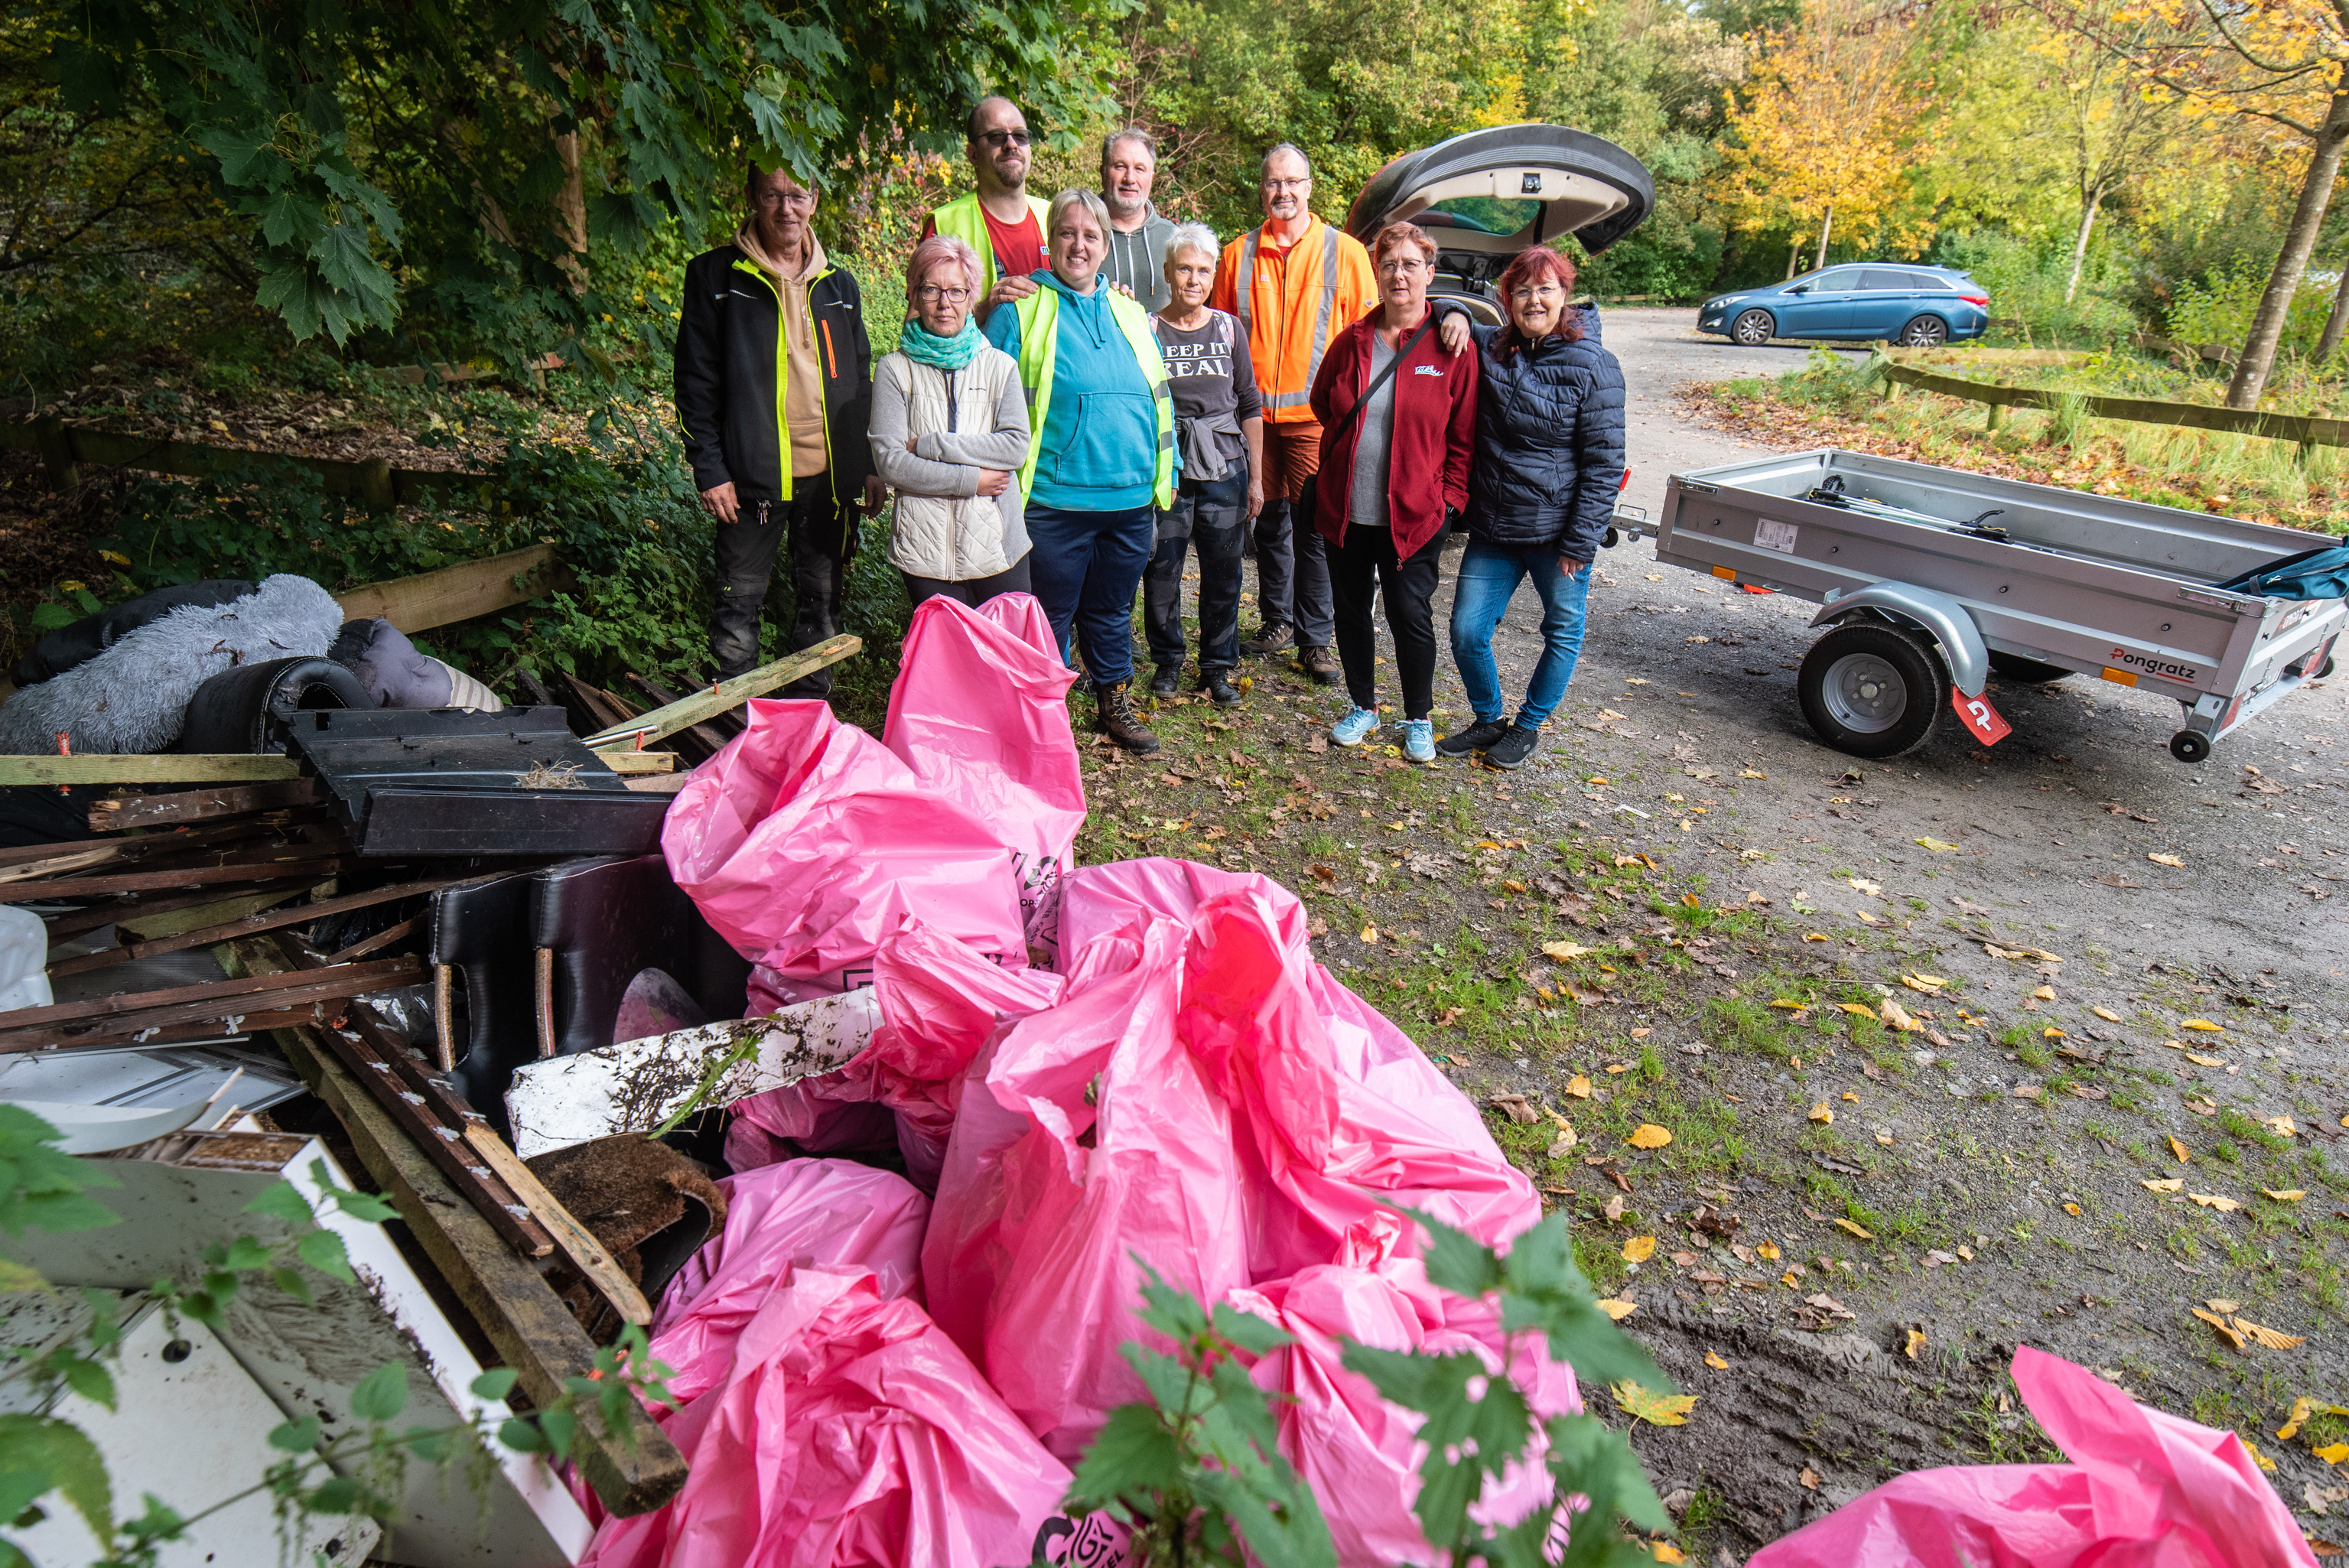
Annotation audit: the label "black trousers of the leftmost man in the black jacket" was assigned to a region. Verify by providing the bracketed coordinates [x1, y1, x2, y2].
[709, 474, 855, 697]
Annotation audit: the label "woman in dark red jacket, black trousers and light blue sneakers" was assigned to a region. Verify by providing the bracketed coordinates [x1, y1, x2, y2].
[1313, 223, 1478, 763]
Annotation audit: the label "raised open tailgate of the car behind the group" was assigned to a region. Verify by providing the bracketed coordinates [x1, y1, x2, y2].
[1346, 125, 1656, 324]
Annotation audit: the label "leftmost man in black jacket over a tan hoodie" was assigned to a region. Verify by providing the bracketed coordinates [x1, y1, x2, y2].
[676, 164, 881, 697]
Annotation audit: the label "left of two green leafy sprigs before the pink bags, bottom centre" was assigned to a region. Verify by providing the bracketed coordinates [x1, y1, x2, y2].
[1066, 1258, 1336, 1568]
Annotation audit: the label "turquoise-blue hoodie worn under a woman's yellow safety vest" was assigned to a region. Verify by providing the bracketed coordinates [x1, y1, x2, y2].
[984, 268, 1158, 512]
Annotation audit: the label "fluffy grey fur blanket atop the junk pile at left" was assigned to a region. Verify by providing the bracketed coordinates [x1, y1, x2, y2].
[0, 573, 343, 756]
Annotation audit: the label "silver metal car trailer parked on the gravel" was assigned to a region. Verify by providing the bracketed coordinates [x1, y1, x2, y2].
[1616, 448, 2349, 763]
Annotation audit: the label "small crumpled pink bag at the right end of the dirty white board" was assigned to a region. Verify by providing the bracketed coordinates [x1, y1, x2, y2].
[726, 922, 1062, 1192]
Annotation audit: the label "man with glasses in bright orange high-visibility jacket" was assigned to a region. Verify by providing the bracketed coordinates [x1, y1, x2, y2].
[1210, 141, 1379, 685]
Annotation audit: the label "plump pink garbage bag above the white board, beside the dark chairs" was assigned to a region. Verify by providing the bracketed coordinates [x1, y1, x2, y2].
[660, 702, 1026, 1000]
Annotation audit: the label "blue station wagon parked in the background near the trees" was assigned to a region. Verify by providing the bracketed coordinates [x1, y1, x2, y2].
[1696, 263, 1989, 347]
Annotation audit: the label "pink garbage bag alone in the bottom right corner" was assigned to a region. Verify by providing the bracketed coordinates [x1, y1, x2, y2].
[1748, 1345, 2316, 1568]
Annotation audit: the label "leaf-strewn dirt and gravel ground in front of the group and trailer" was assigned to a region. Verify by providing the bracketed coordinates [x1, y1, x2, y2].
[1099, 310, 2349, 1563]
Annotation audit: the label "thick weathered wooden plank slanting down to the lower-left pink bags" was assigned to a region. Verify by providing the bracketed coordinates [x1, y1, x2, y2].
[239, 944, 686, 1516]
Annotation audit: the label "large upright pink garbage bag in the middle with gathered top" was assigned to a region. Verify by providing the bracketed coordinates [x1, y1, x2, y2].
[921, 920, 1250, 1458]
